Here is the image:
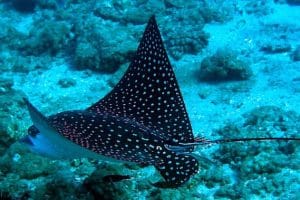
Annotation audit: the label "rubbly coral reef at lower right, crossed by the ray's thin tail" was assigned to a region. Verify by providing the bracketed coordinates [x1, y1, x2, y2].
[214, 106, 300, 198]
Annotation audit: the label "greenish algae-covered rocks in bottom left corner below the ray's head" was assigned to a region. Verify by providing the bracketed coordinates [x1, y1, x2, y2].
[0, 143, 95, 199]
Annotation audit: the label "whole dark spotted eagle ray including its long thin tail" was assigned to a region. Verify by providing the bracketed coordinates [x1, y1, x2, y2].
[22, 16, 299, 187]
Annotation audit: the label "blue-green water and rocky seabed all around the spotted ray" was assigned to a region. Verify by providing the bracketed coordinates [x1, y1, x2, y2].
[0, 0, 300, 199]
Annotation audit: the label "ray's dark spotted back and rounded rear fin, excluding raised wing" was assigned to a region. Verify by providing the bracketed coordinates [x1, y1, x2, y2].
[29, 108, 198, 187]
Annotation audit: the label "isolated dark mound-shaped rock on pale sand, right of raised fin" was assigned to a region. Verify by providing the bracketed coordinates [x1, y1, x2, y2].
[199, 50, 252, 81]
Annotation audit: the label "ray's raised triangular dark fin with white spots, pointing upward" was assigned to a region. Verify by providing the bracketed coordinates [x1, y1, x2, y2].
[88, 16, 194, 142]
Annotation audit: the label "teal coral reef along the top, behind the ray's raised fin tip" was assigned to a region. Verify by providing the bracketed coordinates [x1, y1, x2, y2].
[0, 0, 226, 73]
